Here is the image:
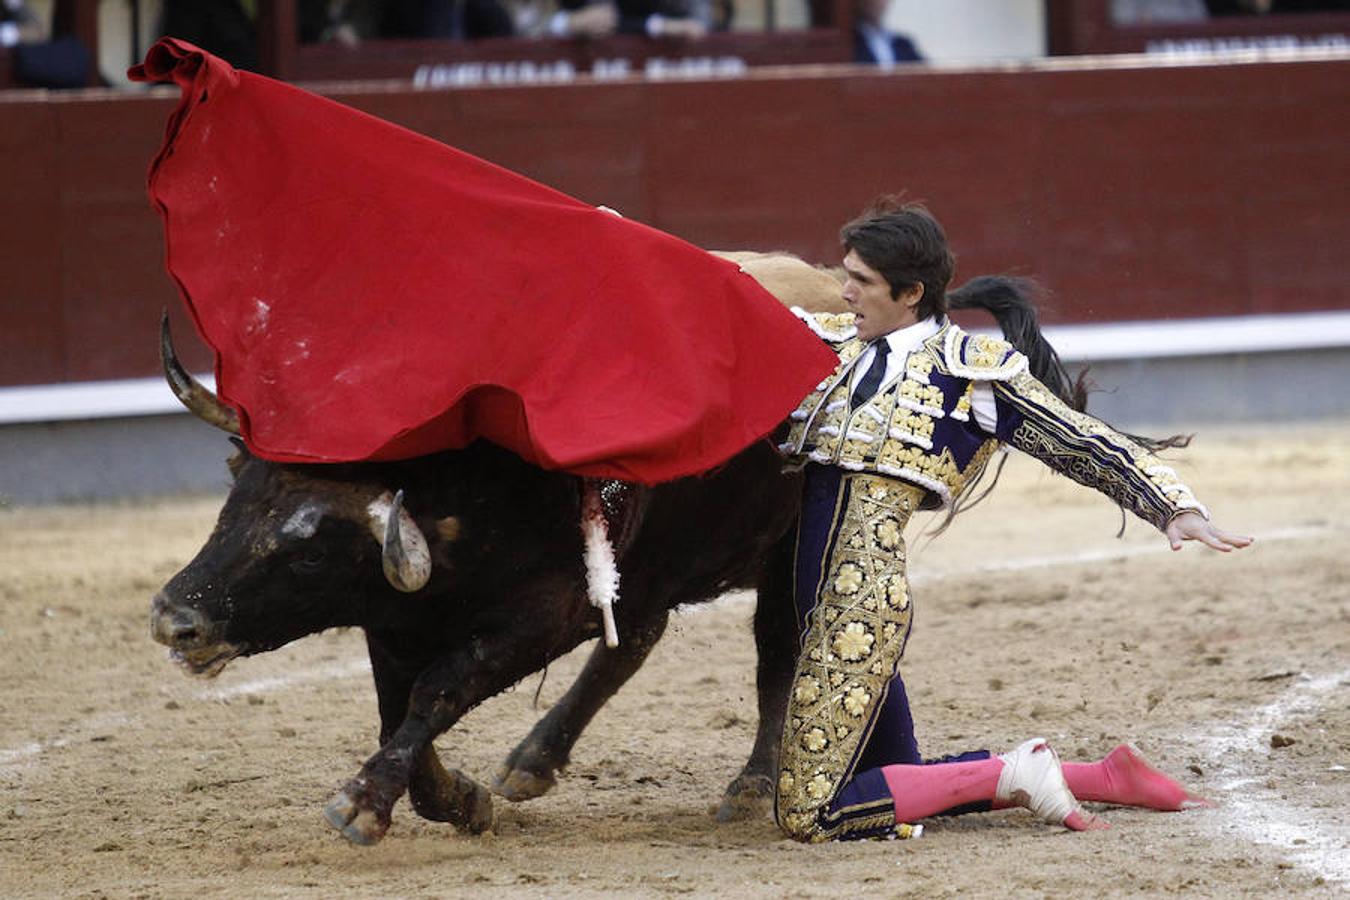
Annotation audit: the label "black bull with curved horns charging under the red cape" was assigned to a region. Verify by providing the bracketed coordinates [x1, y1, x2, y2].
[151, 319, 801, 843]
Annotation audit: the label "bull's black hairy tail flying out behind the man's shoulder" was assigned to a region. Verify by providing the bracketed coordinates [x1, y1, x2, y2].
[946, 275, 1191, 452]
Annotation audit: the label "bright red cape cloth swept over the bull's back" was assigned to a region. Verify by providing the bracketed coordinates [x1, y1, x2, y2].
[130, 39, 838, 483]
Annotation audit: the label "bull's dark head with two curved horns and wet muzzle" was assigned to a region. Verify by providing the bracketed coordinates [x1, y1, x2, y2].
[151, 318, 447, 675]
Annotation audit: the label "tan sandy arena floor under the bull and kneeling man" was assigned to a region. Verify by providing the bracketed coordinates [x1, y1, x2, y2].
[0, 425, 1350, 900]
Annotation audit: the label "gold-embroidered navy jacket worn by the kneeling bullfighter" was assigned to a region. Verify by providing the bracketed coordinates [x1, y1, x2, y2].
[779, 309, 1208, 530]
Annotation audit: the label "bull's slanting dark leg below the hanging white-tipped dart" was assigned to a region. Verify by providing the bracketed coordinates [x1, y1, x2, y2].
[493, 604, 670, 803]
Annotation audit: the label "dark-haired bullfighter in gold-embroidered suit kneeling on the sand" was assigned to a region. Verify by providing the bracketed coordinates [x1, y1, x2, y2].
[775, 200, 1251, 842]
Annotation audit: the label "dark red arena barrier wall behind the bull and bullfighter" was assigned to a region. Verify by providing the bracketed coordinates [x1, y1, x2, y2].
[0, 61, 1350, 385]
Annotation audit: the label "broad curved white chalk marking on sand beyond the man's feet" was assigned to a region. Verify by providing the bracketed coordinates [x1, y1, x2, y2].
[1183, 669, 1350, 885]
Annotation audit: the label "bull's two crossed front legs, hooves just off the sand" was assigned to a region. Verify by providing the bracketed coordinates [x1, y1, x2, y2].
[324, 634, 537, 845]
